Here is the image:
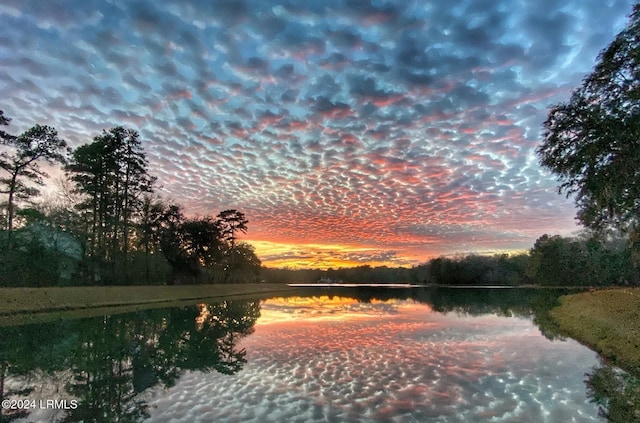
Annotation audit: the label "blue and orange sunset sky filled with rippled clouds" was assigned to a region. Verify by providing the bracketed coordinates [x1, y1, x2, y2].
[0, 0, 632, 268]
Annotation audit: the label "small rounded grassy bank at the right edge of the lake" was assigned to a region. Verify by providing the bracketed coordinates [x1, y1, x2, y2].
[551, 288, 640, 372]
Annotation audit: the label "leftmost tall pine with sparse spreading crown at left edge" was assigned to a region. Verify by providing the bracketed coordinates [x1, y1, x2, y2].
[0, 122, 67, 232]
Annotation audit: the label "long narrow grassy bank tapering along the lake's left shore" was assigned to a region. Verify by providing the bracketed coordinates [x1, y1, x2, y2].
[0, 284, 298, 324]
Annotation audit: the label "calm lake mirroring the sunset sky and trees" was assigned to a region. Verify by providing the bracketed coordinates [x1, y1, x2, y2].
[0, 288, 632, 423]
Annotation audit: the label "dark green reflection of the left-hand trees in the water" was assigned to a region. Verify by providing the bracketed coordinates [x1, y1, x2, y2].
[0, 301, 260, 422]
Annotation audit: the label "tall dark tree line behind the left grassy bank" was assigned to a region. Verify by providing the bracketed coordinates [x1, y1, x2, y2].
[0, 111, 260, 286]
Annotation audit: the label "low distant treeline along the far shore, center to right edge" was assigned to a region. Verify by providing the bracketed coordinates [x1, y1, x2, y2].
[262, 235, 640, 286]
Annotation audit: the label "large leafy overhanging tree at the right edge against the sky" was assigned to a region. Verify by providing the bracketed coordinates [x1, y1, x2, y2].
[537, 4, 640, 238]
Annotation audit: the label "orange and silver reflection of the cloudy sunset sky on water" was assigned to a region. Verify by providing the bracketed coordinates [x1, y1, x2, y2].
[150, 297, 601, 422]
